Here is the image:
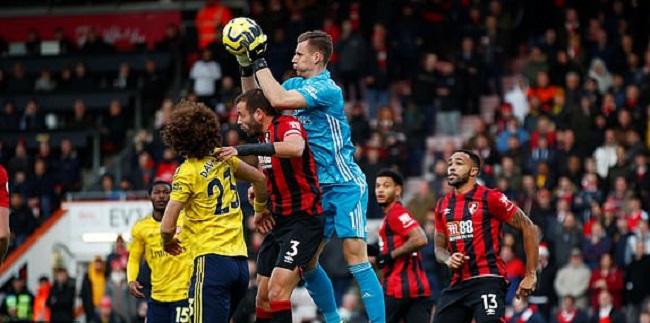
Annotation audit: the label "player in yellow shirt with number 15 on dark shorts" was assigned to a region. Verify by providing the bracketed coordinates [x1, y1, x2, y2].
[126, 181, 192, 323]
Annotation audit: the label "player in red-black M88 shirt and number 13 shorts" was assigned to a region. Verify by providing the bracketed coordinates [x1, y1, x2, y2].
[433, 149, 538, 323]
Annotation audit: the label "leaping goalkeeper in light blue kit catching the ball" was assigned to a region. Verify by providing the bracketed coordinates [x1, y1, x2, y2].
[237, 27, 386, 322]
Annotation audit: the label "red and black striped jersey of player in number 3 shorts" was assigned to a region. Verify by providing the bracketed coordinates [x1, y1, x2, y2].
[259, 116, 323, 216]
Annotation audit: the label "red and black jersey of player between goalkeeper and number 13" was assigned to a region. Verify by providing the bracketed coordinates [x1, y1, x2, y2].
[379, 203, 431, 298]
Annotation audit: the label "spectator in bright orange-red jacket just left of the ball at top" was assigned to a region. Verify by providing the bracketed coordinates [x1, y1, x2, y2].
[195, 0, 233, 50]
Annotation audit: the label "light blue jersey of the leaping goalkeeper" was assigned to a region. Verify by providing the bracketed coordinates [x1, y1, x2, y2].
[282, 70, 366, 184]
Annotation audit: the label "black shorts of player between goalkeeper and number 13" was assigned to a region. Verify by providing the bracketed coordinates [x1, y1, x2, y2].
[384, 296, 433, 323]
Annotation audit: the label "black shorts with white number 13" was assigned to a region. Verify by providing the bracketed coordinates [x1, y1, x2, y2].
[433, 277, 508, 323]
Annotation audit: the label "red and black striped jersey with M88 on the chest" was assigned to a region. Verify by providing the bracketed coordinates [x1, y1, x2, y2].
[435, 184, 517, 285]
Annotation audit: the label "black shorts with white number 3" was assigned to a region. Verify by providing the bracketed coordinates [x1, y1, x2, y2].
[257, 215, 324, 277]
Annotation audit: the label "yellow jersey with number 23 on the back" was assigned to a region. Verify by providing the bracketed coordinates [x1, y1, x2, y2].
[170, 156, 248, 259]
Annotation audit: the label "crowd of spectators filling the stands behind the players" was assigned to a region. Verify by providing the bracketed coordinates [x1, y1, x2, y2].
[0, 0, 650, 322]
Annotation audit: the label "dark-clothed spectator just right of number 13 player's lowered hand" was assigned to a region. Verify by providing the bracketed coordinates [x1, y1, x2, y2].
[528, 242, 557, 319]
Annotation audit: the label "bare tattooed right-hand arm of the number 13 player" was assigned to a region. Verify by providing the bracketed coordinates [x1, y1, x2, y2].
[506, 208, 539, 297]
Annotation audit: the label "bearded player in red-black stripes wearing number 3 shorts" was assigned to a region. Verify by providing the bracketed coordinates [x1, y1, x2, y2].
[216, 89, 324, 323]
